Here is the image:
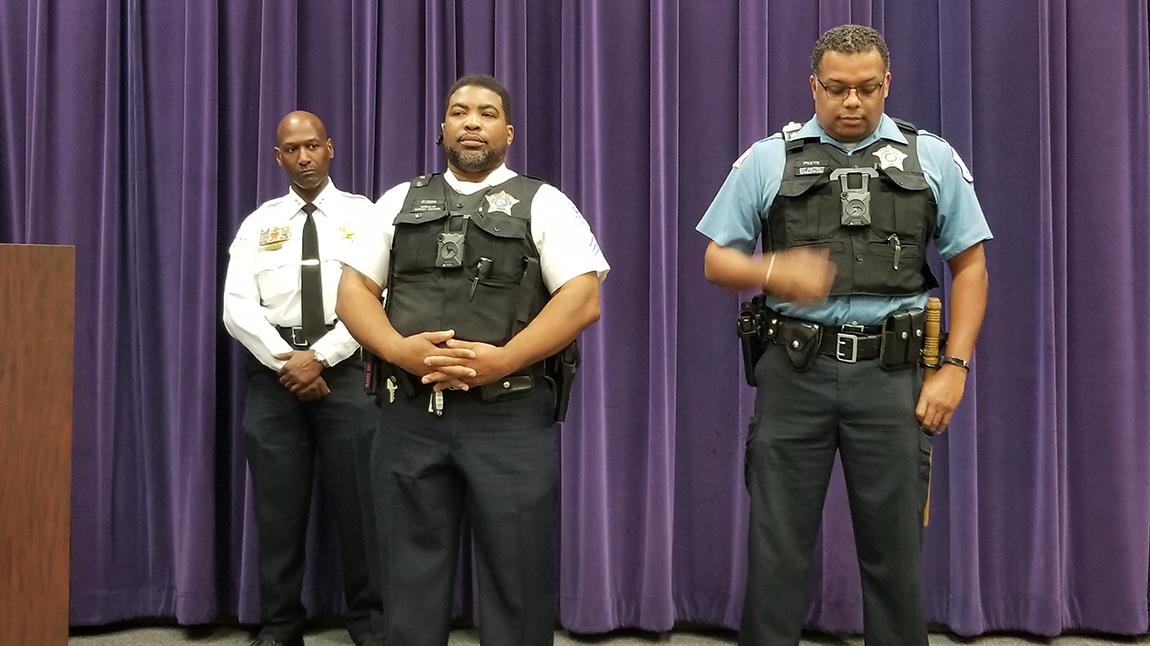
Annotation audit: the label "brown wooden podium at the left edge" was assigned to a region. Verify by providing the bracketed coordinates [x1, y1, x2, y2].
[0, 245, 76, 645]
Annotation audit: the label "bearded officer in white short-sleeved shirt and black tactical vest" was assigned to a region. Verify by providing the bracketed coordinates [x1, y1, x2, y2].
[338, 75, 610, 646]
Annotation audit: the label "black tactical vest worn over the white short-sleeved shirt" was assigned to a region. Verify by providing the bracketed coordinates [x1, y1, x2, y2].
[386, 170, 550, 346]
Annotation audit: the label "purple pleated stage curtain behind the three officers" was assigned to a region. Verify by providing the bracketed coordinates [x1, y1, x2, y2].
[0, 0, 1150, 635]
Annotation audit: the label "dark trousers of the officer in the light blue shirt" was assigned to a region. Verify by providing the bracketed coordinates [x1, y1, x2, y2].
[738, 346, 930, 646]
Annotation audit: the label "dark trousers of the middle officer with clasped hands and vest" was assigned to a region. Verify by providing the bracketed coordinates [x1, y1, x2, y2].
[371, 385, 559, 646]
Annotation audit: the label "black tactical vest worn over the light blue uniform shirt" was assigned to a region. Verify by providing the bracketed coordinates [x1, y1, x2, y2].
[762, 120, 938, 295]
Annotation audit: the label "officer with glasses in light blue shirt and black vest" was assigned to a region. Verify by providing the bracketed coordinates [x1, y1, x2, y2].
[698, 25, 991, 646]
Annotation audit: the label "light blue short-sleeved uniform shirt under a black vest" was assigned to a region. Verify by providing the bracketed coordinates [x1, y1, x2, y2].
[696, 115, 992, 325]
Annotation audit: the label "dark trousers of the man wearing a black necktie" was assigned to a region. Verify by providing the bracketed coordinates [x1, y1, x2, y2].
[244, 357, 382, 644]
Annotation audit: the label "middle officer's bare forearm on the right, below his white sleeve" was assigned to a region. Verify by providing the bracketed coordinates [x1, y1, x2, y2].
[504, 271, 599, 371]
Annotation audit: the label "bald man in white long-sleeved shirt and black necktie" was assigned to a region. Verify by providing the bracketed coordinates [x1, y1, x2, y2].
[223, 111, 381, 646]
